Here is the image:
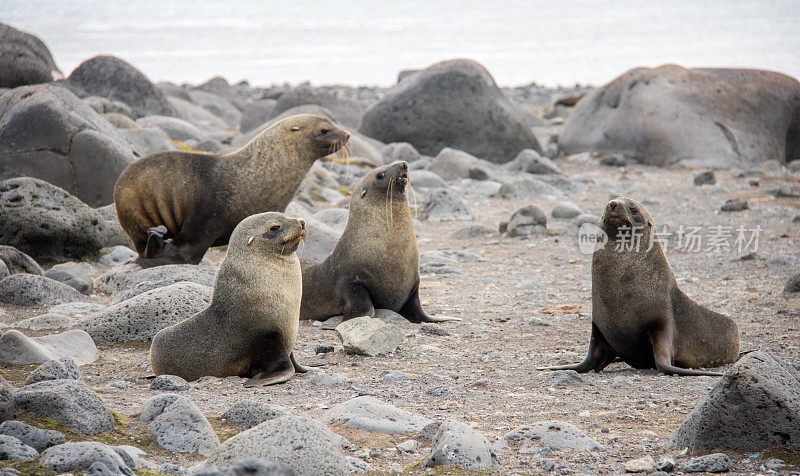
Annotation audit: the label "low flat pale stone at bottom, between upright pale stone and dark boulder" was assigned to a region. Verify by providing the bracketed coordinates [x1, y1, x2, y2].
[494, 421, 603, 454]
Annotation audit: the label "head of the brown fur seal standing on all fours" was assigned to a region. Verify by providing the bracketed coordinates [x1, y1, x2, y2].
[274, 114, 350, 157]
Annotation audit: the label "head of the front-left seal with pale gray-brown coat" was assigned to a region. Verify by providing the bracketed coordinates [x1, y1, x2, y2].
[230, 212, 306, 255]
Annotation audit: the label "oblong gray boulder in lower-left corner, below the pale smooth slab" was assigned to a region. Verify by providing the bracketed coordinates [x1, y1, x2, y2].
[14, 379, 114, 435]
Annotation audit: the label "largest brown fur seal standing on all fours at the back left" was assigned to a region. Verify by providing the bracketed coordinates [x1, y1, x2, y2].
[114, 114, 350, 267]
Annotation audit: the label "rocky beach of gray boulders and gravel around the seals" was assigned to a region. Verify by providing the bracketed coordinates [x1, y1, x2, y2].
[0, 20, 800, 475]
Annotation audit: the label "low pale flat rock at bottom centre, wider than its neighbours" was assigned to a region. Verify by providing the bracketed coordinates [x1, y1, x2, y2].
[322, 396, 433, 434]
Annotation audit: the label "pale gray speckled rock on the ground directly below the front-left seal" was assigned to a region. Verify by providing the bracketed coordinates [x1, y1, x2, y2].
[140, 393, 219, 456]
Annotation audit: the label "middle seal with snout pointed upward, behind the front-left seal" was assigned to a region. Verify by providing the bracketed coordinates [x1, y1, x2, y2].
[300, 162, 460, 322]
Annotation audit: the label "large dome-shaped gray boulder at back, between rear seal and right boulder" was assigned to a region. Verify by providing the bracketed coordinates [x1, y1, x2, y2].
[358, 59, 541, 162]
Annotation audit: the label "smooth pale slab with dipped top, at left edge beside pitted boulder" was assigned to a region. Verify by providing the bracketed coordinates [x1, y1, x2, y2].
[0, 329, 100, 365]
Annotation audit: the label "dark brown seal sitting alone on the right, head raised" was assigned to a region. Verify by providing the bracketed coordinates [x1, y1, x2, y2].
[540, 198, 739, 376]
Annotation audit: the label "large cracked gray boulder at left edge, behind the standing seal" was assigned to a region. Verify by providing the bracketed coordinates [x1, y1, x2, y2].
[0, 84, 138, 206]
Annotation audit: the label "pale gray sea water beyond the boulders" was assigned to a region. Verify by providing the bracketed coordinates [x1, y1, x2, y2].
[0, 0, 800, 86]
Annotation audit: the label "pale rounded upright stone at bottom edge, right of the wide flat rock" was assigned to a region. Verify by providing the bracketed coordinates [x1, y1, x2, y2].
[425, 420, 501, 470]
